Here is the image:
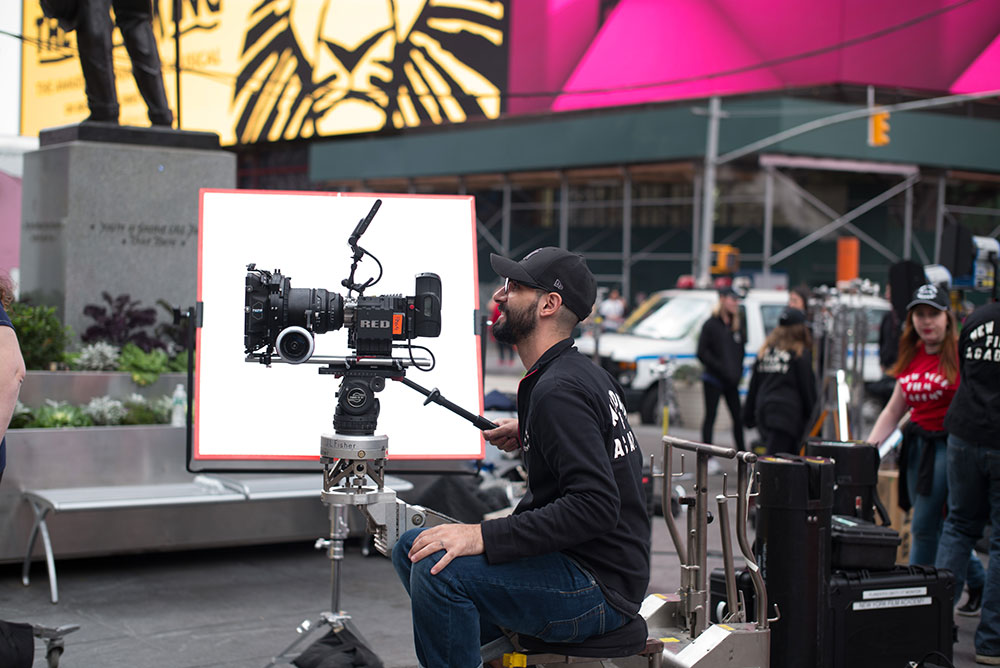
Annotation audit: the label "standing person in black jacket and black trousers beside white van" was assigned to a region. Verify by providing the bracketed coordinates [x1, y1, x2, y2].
[698, 288, 746, 450]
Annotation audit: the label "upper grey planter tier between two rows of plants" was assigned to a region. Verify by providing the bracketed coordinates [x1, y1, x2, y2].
[19, 371, 187, 408]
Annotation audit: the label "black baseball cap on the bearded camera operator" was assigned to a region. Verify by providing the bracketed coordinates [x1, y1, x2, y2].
[490, 246, 597, 320]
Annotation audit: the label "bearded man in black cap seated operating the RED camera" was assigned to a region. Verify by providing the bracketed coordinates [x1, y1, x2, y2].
[392, 247, 650, 668]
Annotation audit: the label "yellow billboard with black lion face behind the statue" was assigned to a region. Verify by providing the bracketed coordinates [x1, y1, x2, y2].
[21, 0, 509, 144]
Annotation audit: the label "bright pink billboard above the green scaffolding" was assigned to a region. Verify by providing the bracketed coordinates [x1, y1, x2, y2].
[508, 0, 1000, 113]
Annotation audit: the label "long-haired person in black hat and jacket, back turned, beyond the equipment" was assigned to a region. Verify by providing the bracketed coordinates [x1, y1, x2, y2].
[743, 308, 816, 455]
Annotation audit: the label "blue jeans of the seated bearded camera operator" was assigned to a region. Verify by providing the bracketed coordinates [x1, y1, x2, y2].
[392, 529, 627, 668]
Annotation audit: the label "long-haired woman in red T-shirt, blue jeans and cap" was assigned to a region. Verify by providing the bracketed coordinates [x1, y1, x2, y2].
[865, 284, 985, 588]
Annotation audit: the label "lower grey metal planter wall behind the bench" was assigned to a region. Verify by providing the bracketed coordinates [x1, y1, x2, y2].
[0, 422, 330, 562]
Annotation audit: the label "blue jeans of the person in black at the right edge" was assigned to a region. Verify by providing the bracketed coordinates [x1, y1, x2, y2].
[935, 436, 1000, 656]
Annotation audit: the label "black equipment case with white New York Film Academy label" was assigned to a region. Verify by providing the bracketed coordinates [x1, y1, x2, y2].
[826, 566, 955, 668]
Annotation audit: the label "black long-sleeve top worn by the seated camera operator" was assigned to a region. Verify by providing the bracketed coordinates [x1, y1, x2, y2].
[482, 339, 650, 615]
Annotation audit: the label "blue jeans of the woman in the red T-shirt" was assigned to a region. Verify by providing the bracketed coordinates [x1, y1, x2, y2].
[906, 437, 986, 595]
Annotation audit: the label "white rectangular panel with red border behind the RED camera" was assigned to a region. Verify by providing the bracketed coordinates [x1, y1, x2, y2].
[190, 190, 484, 470]
